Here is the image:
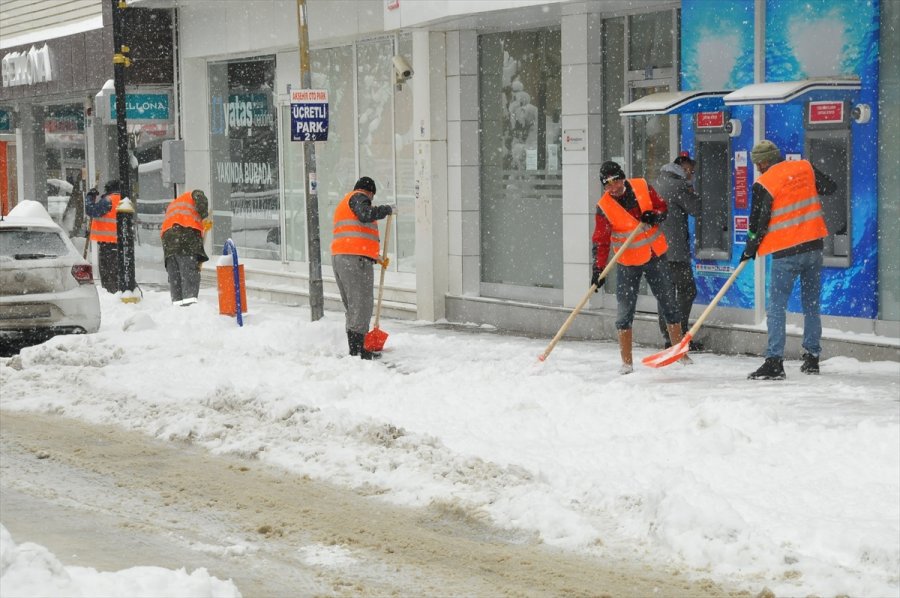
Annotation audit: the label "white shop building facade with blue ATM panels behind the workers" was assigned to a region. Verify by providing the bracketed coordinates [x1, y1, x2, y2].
[0, 0, 900, 359]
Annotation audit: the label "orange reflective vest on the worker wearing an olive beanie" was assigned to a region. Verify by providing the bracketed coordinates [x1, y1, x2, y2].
[756, 160, 828, 255]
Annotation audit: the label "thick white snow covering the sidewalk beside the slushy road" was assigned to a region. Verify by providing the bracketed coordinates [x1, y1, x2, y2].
[0, 289, 900, 597]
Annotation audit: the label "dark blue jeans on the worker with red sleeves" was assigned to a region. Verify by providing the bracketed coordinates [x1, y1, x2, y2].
[616, 256, 684, 332]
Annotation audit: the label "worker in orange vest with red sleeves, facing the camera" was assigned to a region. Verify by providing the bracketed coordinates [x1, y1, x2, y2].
[591, 161, 691, 375]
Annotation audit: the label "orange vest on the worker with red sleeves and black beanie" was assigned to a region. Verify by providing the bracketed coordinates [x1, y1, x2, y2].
[597, 179, 669, 266]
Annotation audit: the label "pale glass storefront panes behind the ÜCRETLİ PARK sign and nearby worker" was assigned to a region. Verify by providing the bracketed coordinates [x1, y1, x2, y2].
[283, 41, 415, 272]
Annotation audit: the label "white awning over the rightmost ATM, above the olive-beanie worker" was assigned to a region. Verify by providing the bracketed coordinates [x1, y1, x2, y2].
[724, 76, 861, 106]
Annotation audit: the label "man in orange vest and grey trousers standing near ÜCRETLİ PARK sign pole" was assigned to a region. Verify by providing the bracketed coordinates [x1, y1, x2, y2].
[331, 176, 397, 359]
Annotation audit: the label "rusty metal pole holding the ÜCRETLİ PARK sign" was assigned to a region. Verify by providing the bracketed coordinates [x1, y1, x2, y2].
[297, 0, 325, 322]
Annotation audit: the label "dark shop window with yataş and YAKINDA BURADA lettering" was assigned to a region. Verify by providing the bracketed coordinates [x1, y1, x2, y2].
[208, 56, 281, 259]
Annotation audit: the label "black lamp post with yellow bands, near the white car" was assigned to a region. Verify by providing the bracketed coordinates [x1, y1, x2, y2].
[111, 0, 140, 303]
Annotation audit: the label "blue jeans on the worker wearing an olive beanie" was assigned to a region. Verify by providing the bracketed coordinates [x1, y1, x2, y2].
[766, 249, 822, 359]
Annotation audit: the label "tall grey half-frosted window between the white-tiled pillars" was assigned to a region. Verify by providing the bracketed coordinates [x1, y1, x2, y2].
[478, 29, 563, 289]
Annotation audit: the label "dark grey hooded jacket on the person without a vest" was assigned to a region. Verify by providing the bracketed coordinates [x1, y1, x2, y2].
[653, 163, 700, 262]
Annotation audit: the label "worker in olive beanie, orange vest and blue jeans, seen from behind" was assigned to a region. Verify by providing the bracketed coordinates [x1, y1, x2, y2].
[741, 139, 837, 380]
